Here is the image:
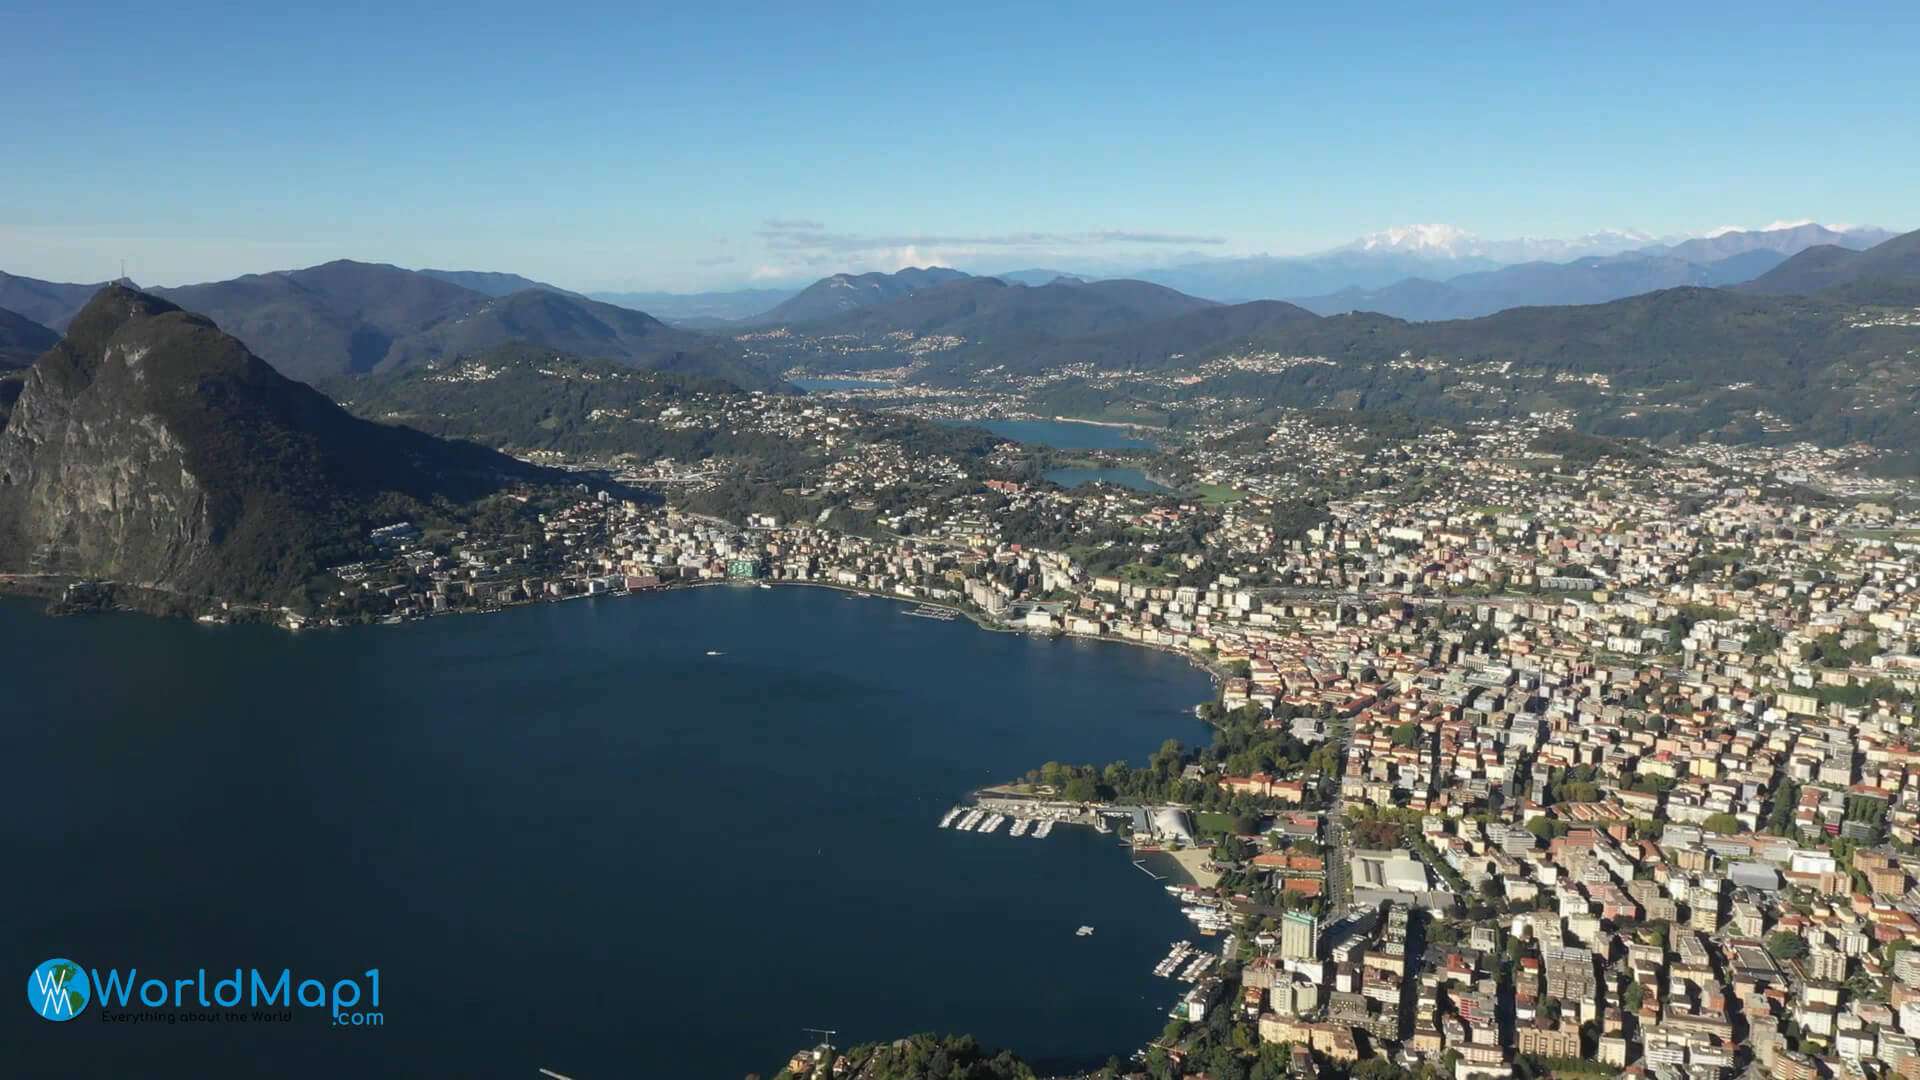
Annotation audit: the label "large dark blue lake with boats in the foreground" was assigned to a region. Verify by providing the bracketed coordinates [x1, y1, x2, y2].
[0, 586, 1210, 1080]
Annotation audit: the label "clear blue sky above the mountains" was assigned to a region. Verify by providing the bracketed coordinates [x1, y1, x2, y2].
[0, 0, 1920, 290]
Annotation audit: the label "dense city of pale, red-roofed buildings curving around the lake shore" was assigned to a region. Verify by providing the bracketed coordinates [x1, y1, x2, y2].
[161, 376, 1920, 1080]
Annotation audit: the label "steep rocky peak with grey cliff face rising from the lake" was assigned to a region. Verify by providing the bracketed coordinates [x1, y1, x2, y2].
[0, 286, 545, 607]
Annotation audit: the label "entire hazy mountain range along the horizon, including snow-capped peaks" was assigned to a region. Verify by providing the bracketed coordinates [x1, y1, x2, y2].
[0, 223, 1901, 390]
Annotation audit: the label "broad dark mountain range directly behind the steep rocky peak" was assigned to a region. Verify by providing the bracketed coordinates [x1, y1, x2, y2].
[0, 259, 783, 390]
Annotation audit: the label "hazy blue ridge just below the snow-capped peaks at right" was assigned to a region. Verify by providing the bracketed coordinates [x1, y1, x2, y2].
[1296, 248, 1784, 321]
